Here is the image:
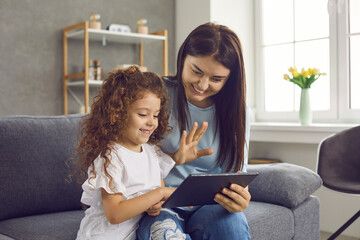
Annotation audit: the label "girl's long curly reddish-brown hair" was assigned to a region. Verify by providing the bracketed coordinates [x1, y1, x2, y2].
[75, 66, 169, 187]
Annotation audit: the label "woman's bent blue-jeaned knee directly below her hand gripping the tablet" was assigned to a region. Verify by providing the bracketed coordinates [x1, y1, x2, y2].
[186, 204, 250, 240]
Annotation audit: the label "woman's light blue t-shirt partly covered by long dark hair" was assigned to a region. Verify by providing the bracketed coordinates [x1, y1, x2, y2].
[161, 80, 250, 187]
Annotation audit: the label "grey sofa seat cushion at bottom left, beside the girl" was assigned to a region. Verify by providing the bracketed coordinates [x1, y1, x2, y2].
[0, 210, 84, 240]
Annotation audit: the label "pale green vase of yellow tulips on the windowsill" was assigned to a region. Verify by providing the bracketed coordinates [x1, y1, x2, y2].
[284, 67, 326, 125]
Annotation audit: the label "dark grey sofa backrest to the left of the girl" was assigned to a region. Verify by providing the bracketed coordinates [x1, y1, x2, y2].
[0, 114, 84, 220]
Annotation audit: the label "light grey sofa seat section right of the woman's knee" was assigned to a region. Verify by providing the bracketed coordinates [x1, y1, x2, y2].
[244, 201, 295, 240]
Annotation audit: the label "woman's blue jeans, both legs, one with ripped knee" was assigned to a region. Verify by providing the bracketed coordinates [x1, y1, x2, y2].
[136, 204, 250, 240]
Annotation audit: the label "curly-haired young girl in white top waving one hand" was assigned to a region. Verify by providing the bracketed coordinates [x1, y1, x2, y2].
[77, 66, 206, 239]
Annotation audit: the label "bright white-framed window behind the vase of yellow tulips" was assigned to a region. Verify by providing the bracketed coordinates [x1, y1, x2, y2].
[255, 0, 360, 122]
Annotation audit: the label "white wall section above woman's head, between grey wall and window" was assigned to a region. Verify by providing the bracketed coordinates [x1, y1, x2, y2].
[174, 0, 255, 107]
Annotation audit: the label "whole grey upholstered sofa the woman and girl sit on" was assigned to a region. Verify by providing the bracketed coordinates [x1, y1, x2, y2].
[0, 115, 322, 240]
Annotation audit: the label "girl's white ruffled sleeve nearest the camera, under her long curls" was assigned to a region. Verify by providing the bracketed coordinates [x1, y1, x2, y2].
[81, 154, 127, 206]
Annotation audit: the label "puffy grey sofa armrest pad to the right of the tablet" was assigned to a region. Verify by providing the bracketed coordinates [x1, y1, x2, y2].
[247, 163, 322, 208]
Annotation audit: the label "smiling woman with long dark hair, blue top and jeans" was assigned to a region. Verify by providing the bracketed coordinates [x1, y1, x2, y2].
[137, 23, 251, 240]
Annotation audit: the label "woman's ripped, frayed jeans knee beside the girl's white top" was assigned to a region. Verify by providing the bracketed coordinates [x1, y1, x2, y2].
[136, 209, 191, 240]
